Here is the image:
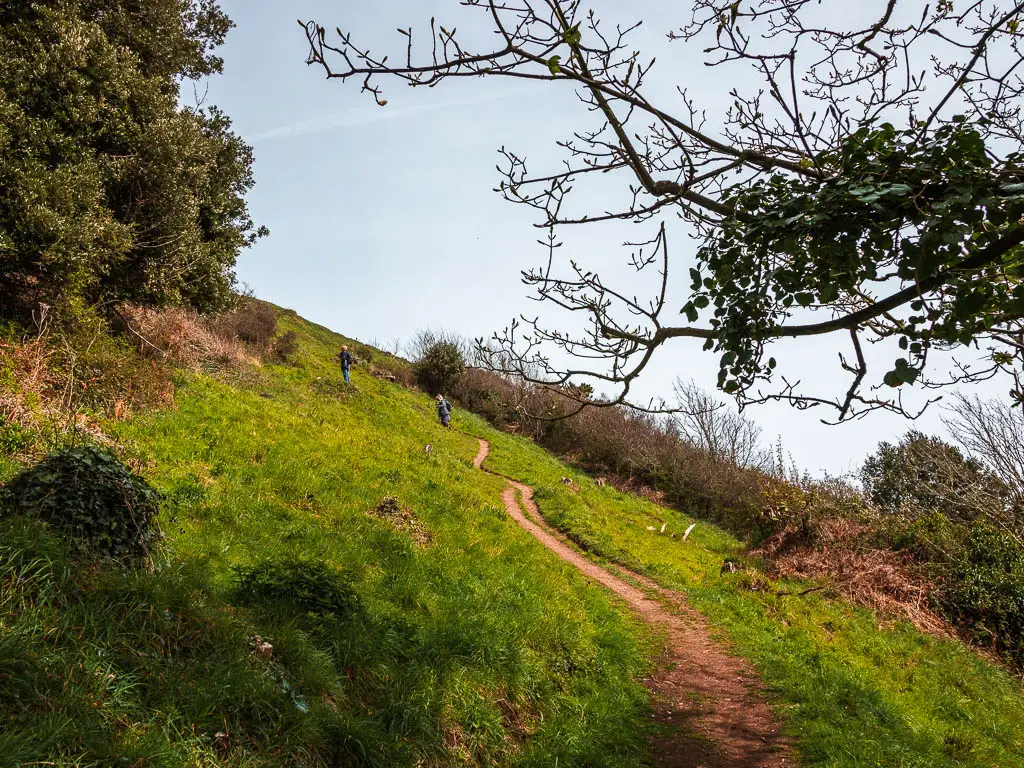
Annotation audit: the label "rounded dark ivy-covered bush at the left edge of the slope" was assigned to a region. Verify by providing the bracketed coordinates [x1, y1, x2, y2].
[0, 447, 160, 561]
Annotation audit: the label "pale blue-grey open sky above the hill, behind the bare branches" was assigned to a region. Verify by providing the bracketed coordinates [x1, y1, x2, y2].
[203, 0, 1006, 481]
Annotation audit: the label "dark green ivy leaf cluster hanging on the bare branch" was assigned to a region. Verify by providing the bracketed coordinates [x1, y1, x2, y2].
[683, 120, 1024, 391]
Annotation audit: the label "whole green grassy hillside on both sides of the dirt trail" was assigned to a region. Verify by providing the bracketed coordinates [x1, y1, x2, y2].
[0, 313, 1024, 768]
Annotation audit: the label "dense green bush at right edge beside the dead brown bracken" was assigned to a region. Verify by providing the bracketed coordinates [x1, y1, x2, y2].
[939, 525, 1024, 665]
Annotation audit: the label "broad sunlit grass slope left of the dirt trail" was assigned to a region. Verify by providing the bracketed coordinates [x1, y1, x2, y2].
[0, 316, 652, 768]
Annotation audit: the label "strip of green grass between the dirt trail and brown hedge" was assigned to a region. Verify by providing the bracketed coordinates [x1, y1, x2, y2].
[473, 423, 1024, 768]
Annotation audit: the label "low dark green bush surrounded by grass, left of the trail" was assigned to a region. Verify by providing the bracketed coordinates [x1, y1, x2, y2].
[234, 560, 358, 618]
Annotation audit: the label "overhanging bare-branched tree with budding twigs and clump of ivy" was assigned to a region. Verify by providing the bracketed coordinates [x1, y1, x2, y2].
[304, 0, 1024, 420]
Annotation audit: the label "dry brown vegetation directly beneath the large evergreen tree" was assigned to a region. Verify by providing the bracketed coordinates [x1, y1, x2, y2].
[0, 298, 294, 459]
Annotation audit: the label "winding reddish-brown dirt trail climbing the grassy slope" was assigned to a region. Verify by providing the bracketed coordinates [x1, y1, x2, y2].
[473, 440, 797, 768]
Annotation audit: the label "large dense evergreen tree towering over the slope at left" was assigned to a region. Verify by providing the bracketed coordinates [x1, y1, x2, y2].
[0, 0, 264, 312]
